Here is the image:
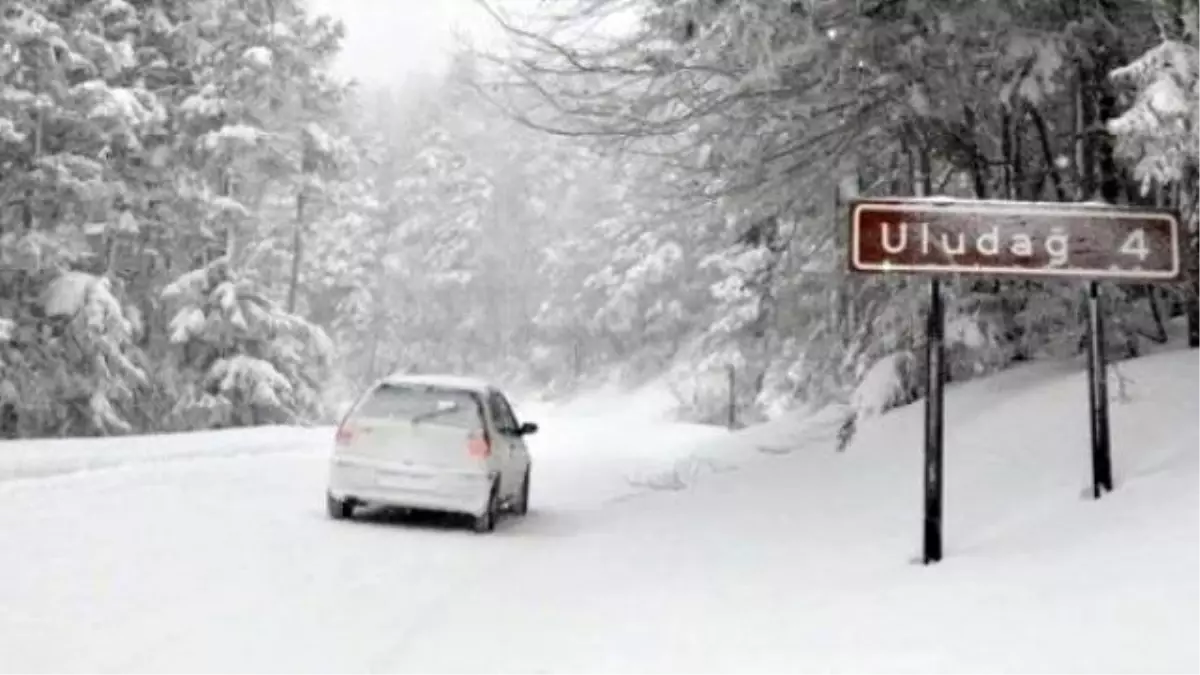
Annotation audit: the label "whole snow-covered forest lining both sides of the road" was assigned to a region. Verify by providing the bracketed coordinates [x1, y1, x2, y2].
[0, 0, 1200, 438]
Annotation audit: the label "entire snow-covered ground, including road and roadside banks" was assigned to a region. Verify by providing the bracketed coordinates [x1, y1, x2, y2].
[0, 352, 1200, 675]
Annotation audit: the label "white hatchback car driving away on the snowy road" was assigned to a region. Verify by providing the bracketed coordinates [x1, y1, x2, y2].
[325, 375, 538, 532]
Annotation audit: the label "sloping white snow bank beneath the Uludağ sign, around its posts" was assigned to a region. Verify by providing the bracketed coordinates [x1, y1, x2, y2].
[424, 351, 1200, 675]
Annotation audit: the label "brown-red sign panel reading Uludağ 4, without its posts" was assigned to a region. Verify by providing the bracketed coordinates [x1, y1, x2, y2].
[850, 198, 1183, 281]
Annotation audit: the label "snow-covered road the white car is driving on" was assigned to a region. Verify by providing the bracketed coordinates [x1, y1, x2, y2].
[0, 393, 721, 675]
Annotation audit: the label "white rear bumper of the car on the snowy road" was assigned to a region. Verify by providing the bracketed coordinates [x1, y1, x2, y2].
[329, 459, 492, 515]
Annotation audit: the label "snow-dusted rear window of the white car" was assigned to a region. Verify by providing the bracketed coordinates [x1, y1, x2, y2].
[354, 384, 481, 429]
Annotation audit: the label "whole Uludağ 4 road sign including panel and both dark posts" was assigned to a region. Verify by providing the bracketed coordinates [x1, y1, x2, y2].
[848, 198, 1184, 565]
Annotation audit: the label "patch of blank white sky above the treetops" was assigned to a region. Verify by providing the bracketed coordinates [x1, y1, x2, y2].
[308, 0, 494, 85]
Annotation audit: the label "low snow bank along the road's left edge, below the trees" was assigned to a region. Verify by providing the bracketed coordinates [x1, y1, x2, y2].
[0, 426, 334, 484]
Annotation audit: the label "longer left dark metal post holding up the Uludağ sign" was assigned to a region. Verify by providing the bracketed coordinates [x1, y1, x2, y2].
[923, 277, 946, 565]
